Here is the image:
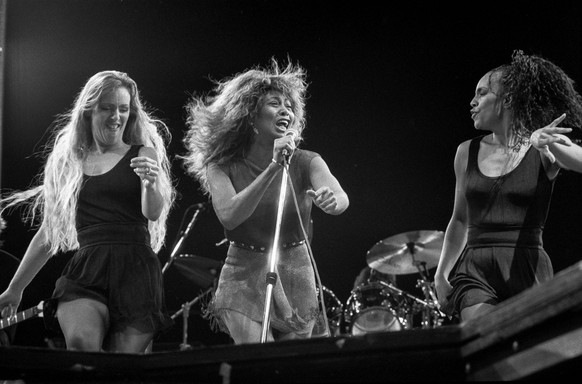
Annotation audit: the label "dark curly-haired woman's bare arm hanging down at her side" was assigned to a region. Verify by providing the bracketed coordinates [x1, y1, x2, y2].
[435, 141, 469, 305]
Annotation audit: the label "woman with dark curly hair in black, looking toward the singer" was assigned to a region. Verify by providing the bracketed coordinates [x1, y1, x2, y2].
[435, 51, 582, 321]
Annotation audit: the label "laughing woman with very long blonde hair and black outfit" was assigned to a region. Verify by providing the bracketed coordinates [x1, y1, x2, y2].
[0, 71, 175, 353]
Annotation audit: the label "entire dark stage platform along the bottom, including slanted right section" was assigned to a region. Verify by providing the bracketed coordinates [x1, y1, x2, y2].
[0, 262, 582, 383]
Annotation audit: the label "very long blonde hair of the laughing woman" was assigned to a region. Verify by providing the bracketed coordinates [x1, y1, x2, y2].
[0, 71, 176, 255]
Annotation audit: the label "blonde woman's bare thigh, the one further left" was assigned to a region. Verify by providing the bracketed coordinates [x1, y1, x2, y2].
[57, 299, 109, 351]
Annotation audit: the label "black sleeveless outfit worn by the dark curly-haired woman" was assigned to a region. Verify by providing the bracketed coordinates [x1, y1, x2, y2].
[443, 136, 554, 316]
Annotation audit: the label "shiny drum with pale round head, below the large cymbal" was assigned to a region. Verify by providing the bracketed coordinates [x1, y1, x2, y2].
[344, 282, 403, 336]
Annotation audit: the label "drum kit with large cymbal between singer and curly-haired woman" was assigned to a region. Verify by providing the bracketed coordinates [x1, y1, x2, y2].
[314, 231, 445, 336]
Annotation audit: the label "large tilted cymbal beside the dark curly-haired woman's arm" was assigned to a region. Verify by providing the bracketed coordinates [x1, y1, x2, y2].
[366, 231, 444, 275]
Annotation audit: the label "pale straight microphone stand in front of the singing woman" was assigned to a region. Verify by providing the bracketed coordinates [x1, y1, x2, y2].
[261, 156, 289, 343]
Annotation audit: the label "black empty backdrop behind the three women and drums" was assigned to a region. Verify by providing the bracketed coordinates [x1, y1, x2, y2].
[1, 0, 582, 345]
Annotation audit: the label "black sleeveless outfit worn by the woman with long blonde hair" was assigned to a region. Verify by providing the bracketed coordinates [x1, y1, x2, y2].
[53, 145, 172, 333]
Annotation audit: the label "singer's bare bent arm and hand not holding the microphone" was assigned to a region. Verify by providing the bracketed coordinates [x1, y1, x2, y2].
[307, 156, 350, 215]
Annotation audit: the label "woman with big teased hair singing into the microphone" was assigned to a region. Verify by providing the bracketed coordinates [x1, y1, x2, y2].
[184, 59, 349, 344]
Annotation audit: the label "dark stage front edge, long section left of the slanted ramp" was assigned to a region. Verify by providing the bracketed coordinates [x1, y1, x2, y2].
[0, 326, 464, 383]
